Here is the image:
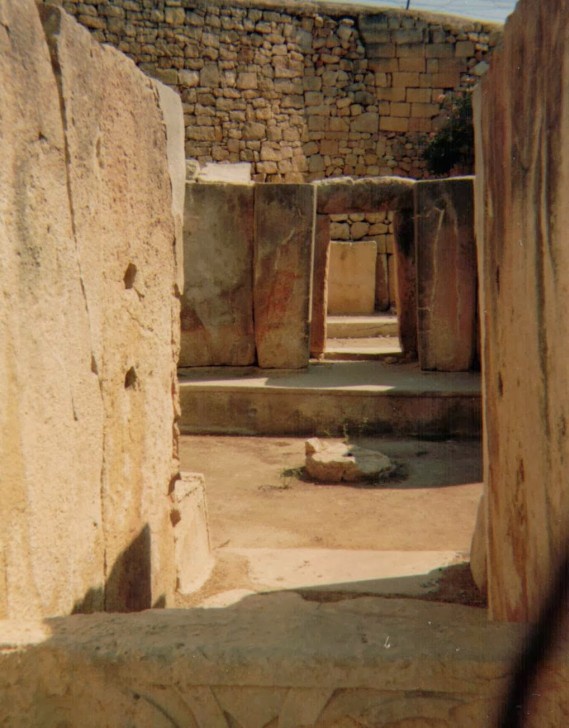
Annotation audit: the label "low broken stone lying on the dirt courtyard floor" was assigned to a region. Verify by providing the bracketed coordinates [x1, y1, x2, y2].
[305, 437, 393, 483]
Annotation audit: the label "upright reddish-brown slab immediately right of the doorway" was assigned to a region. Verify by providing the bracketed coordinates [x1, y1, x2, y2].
[415, 177, 478, 371]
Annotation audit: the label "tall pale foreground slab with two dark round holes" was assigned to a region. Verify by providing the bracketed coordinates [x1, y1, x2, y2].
[35, 6, 180, 611]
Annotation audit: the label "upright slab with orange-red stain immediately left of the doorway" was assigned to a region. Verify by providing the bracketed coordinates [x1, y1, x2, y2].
[253, 184, 316, 369]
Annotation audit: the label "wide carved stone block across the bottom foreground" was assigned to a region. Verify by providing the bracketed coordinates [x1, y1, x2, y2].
[0, 592, 556, 728]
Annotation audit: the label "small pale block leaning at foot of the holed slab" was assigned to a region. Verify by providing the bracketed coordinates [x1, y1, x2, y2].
[172, 473, 214, 594]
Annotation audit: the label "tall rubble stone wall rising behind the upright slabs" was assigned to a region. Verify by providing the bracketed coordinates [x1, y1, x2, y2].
[48, 0, 501, 182]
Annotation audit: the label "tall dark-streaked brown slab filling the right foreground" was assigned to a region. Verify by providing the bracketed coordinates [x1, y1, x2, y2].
[476, 0, 569, 621]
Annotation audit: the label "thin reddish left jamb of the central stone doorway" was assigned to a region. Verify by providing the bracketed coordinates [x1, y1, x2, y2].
[310, 215, 330, 358]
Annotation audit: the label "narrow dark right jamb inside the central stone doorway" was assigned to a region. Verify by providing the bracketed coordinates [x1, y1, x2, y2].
[388, 205, 417, 357]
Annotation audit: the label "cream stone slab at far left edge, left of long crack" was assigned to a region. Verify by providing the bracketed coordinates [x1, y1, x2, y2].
[0, 0, 105, 618]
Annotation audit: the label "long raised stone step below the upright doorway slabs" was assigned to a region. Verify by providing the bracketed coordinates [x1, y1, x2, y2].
[179, 361, 481, 439]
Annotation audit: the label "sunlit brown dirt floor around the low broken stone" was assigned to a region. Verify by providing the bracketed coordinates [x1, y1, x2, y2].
[180, 436, 483, 606]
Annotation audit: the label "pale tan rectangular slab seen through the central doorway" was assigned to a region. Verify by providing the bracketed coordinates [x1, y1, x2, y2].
[328, 240, 377, 315]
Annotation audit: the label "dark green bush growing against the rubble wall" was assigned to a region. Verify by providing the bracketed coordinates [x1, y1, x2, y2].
[423, 91, 474, 175]
